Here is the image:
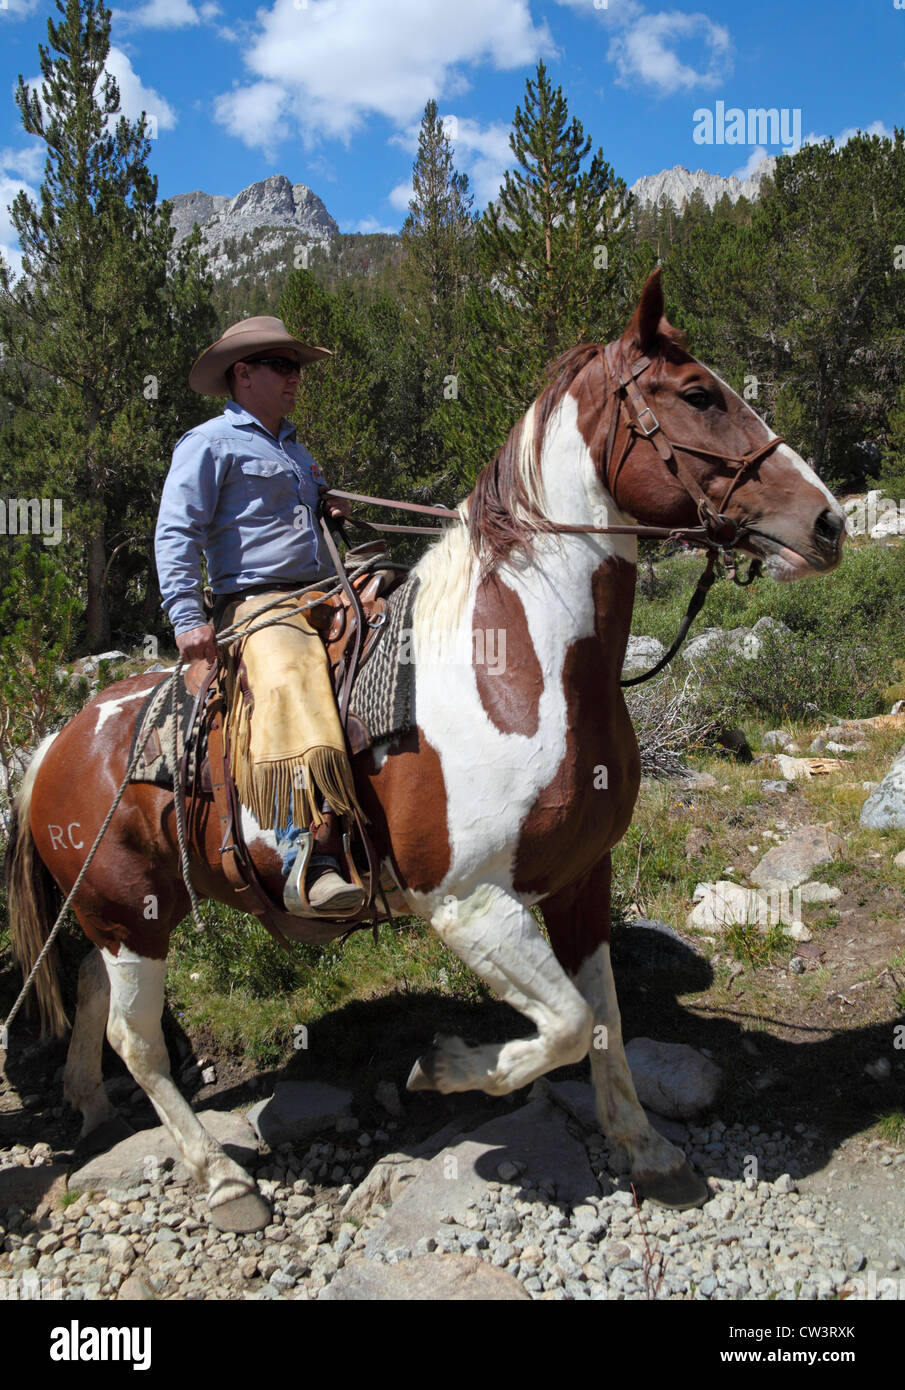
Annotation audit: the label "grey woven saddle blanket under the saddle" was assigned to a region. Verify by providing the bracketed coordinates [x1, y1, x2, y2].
[129, 575, 418, 788]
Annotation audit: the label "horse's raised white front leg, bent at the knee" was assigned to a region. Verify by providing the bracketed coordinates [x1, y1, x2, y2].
[409, 884, 591, 1095]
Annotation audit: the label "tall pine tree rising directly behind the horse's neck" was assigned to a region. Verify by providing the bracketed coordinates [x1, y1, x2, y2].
[443, 63, 635, 481]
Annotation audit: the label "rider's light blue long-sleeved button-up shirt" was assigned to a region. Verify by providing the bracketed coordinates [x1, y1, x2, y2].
[154, 400, 332, 634]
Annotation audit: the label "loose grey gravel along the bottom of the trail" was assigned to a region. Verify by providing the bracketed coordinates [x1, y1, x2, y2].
[0, 1119, 905, 1300]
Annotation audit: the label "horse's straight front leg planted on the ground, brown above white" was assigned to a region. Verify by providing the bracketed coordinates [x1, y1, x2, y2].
[544, 855, 710, 1208]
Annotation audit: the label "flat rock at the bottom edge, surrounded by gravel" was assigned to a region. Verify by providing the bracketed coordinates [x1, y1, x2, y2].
[318, 1254, 530, 1302]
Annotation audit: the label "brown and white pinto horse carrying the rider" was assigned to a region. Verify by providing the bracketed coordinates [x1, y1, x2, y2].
[7, 270, 844, 1232]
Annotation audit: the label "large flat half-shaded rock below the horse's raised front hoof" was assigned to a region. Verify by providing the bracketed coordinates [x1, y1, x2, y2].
[366, 1099, 598, 1258]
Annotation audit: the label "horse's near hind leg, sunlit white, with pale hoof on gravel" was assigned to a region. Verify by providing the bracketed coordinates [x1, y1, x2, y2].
[103, 947, 270, 1232]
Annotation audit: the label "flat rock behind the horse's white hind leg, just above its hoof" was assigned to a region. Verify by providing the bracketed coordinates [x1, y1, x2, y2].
[70, 1111, 257, 1193]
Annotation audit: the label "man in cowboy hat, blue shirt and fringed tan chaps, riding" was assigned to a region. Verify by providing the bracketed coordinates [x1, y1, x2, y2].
[154, 317, 366, 916]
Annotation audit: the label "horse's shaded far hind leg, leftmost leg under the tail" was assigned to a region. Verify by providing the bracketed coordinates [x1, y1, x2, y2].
[63, 947, 132, 1162]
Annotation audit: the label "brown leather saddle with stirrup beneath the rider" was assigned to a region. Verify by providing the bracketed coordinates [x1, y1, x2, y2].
[178, 542, 407, 949]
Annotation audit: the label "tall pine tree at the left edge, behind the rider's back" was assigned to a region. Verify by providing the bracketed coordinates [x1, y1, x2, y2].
[0, 0, 213, 648]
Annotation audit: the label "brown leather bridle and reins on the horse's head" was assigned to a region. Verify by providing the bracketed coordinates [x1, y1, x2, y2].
[329, 343, 784, 685]
